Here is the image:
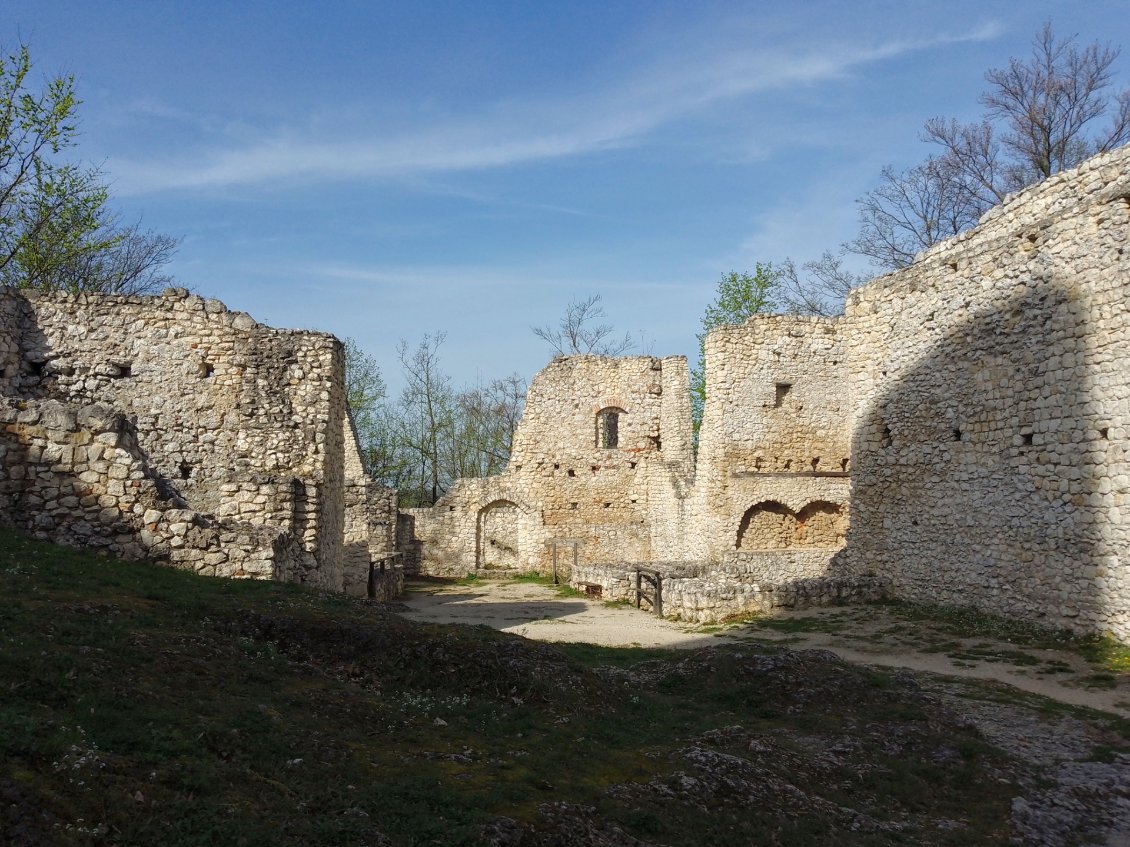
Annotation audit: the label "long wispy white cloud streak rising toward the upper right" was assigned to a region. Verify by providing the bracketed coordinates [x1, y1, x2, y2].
[110, 25, 997, 194]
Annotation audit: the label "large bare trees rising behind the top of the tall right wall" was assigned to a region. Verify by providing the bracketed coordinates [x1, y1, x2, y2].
[844, 24, 1130, 270]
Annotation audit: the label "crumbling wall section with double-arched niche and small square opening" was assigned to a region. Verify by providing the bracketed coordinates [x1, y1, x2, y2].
[688, 315, 851, 578]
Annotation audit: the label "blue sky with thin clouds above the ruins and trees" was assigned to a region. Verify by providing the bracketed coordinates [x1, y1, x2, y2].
[0, 0, 1130, 388]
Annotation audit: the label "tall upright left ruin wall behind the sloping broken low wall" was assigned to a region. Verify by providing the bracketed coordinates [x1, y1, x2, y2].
[0, 289, 392, 590]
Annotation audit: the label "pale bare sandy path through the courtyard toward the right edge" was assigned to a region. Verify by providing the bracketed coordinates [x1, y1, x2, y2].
[402, 580, 1130, 717]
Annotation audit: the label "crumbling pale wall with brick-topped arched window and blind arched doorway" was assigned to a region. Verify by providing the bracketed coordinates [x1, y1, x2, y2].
[402, 356, 693, 576]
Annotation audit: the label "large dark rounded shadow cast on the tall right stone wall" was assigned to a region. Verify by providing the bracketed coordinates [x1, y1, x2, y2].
[836, 274, 1111, 637]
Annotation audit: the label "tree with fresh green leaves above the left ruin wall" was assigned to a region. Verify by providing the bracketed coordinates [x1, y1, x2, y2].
[0, 45, 177, 294]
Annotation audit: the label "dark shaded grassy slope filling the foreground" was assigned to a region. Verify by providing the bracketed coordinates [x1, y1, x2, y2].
[0, 530, 1122, 846]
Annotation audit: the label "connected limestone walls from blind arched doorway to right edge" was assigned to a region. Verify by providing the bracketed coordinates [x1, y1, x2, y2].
[405, 148, 1130, 639]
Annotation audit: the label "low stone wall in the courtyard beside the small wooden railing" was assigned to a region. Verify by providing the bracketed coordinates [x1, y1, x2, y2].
[572, 564, 887, 623]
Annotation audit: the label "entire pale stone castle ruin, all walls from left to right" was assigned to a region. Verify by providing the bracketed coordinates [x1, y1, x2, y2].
[0, 148, 1130, 640]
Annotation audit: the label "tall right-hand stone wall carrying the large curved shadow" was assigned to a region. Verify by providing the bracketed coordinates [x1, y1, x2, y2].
[844, 148, 1130, 639]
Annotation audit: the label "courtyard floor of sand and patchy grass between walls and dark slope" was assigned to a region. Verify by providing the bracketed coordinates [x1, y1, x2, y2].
[401, 579, 1130, 717]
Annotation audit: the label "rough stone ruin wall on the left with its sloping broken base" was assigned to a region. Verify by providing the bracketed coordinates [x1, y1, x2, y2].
[0, 289, 394, 590]
